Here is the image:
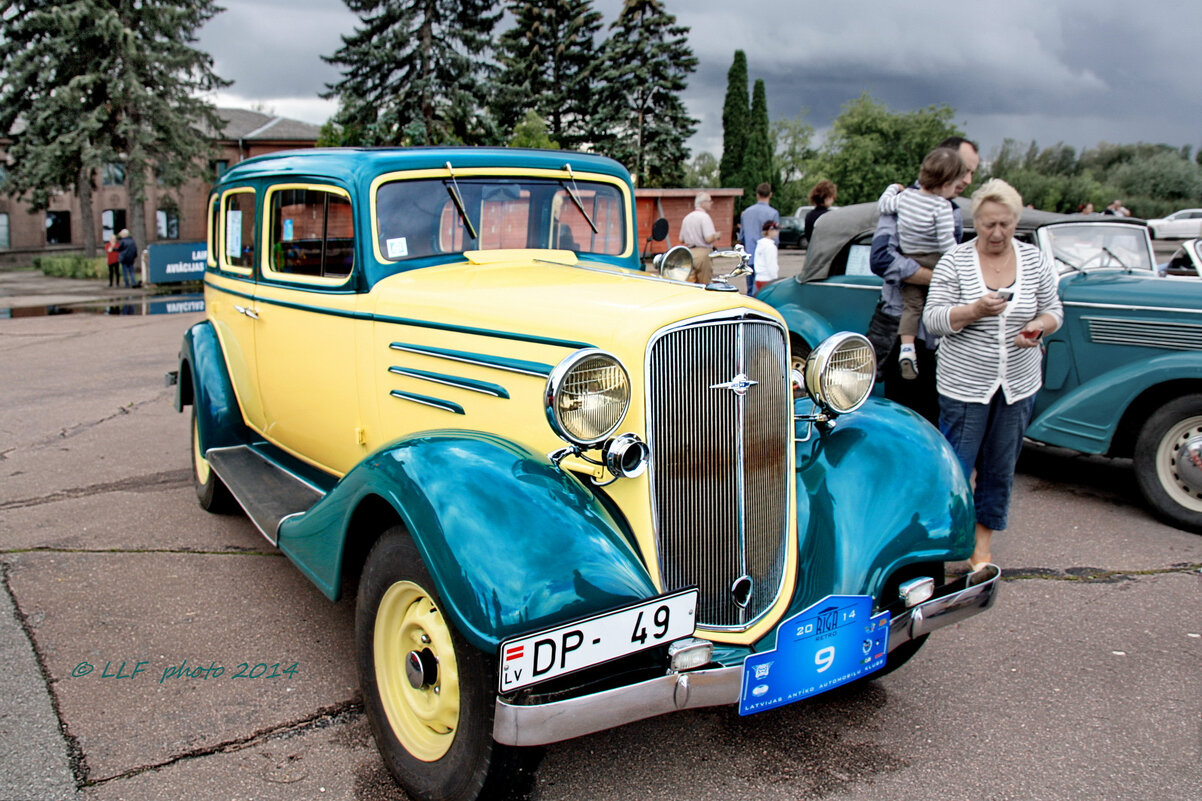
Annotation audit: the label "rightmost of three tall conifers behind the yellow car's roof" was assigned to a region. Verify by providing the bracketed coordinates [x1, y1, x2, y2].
[594, 0, 697, 186]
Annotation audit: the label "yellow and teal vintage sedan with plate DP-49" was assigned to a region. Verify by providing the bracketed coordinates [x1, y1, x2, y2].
[178, 148, 1000, 799]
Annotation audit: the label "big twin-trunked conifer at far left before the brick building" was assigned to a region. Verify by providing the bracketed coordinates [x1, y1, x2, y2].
[0, 0, 228, 255]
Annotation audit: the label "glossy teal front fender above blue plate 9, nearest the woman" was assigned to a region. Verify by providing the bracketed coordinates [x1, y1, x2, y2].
[790, 398, 975, 613]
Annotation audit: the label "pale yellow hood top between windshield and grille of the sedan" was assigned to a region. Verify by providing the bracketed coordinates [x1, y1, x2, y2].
[371, 251, 780, 352]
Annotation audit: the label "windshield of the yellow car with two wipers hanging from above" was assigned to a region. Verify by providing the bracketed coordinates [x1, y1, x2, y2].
[376, 176, 626, 261]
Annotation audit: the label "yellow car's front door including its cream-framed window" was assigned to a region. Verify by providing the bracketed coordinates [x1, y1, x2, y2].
[255, 180, 370, 475]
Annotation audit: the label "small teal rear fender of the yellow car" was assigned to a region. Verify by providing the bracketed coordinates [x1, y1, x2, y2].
[175, 320, 249, 451]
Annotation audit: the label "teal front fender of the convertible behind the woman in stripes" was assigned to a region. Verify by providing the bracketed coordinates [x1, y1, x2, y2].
[1027, 352, 1202, 453]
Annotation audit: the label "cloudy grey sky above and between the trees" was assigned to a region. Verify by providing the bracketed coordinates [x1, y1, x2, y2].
[200, 0, 1202, 156]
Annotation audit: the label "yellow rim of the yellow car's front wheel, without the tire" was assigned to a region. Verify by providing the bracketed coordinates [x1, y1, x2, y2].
[375, 581, 459, 763]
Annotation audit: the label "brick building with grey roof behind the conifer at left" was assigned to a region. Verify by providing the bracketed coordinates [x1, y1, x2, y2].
[0, 108, 320, 262]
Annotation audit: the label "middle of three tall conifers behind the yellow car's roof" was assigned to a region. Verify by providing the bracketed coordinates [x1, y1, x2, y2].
[492, 0, 601, 148]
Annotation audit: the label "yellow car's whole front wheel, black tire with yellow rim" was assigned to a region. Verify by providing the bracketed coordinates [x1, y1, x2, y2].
[355, 526, 542, 801]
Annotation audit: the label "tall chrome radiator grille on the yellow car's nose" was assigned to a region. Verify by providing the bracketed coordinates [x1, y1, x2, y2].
[647, 319, 792, 629]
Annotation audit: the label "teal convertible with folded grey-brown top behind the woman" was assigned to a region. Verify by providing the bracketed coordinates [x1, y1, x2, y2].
[757, 203, 1202, 532]
